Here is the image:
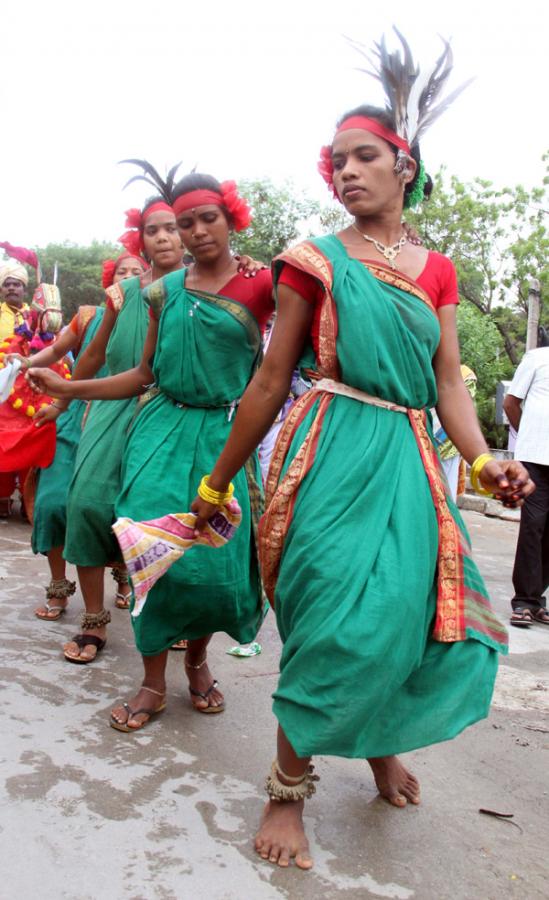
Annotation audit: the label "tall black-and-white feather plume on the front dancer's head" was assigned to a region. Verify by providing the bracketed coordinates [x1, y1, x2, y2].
[347, 28, 473, 146]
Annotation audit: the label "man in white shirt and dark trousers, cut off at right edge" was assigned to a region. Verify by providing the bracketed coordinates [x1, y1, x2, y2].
[503, 347, 549, 628]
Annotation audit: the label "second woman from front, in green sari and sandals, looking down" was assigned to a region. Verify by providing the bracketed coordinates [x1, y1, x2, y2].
[27, 173, 273, 716]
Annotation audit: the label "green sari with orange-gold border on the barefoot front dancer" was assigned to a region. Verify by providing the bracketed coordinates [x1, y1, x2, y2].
[260, 236, 506, 758]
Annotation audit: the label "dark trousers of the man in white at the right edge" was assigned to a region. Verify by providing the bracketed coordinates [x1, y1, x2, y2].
[511, 462, 549, 611]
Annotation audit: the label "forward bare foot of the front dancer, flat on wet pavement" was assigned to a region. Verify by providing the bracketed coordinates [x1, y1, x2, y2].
[255, 800, 313, 869]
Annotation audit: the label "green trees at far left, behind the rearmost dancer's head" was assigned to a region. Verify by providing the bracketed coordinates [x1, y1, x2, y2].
[25, 241, 120, 322]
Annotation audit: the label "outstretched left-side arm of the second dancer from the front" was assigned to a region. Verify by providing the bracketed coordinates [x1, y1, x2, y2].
[28, 318, 158, 400]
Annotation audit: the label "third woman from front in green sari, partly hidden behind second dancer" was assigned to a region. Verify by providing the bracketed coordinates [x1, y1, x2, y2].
[32, 204, 182, 664]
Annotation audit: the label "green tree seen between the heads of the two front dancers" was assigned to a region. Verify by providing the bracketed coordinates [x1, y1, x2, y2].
[233, 179, 318, 263]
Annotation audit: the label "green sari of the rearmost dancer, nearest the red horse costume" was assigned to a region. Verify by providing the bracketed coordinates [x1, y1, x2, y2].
[31, 306, 107, 554]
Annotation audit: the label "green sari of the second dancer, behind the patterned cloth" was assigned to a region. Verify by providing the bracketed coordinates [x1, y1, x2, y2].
[116, 271, 263, 656]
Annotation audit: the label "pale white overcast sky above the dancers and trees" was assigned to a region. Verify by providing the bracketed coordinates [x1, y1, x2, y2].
[0, 0, 549, 255]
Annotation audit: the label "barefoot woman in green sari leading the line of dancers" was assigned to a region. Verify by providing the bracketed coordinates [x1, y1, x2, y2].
[192, 108, 532, 868]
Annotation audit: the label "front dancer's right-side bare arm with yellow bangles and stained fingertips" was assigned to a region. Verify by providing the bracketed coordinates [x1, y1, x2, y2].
[433, 304, 534, 505]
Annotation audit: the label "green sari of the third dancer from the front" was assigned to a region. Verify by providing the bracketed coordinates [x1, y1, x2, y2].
[64, 276, 148, 566]
